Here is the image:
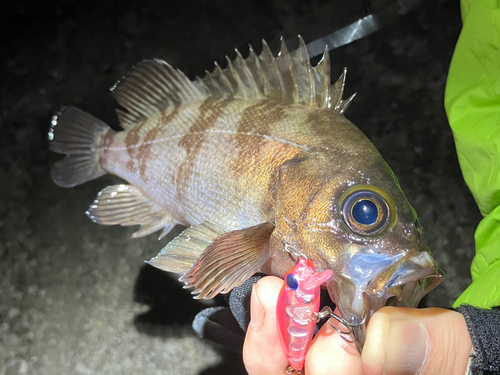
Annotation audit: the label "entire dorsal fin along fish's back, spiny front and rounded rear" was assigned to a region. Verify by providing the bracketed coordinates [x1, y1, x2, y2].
[112, 36, 354, 129]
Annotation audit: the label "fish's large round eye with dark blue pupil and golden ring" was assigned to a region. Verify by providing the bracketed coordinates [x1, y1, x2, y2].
[341, 186, 392, 235]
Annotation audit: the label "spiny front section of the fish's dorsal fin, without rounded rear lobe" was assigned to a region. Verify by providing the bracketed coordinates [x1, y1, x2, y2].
[197, 36, 354, 114]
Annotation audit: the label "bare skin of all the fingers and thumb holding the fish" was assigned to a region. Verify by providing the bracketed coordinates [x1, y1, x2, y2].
[243, 276, 472, 375]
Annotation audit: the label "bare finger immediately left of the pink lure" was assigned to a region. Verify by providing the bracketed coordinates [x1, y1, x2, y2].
[243, 276, 288, 375]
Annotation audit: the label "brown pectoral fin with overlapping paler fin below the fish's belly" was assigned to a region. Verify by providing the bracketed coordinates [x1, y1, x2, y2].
[148, 223, 274, 299]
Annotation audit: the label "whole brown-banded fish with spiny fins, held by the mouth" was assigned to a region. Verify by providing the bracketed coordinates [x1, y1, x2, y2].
[49, 37, 444, 351]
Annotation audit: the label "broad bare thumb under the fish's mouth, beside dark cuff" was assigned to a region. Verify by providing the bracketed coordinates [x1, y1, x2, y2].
[362, 307, 472, 375]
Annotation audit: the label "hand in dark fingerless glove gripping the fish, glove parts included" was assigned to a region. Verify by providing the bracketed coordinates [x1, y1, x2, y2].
[193, 275, 500, 374]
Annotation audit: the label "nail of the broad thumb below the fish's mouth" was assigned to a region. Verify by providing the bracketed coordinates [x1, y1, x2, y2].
[383, 320, 429, 375]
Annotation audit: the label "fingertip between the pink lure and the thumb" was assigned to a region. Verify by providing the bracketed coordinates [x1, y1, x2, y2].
[305, 309, 363, 375]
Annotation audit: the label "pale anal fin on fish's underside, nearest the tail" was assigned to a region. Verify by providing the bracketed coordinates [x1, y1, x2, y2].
[86, 184, 177, 239]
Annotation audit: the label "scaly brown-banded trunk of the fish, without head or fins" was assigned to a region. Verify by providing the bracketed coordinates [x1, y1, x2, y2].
[90, 98, 376, 231]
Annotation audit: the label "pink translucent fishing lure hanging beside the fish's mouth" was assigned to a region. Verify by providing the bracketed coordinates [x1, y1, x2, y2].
[276, 257, 332, 372]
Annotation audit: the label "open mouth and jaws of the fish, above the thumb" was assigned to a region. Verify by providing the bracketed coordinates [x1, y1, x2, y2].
[327, 251, 444, 353]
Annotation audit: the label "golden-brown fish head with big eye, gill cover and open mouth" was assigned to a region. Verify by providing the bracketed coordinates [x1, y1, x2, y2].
[276, 153, 443, 351]
